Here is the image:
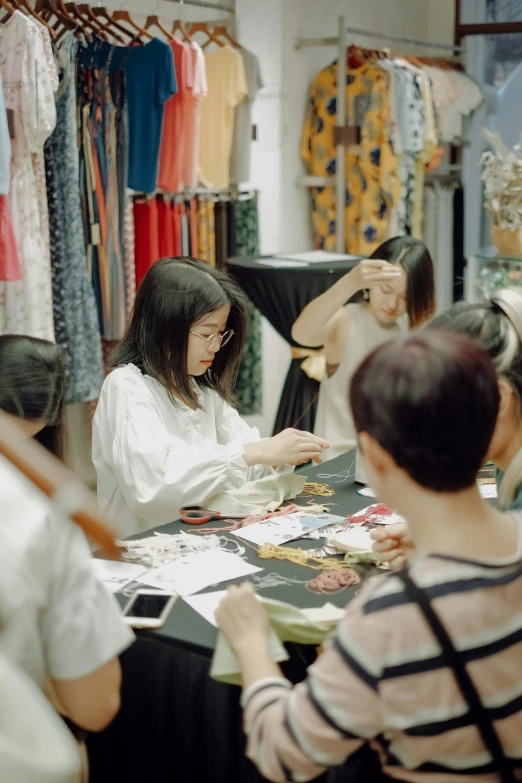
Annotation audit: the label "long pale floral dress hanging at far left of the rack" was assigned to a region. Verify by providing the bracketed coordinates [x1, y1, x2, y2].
[0, 11, 57, 340]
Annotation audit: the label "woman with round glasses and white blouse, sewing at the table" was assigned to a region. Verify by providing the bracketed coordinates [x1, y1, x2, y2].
[93, 258, 328, 537]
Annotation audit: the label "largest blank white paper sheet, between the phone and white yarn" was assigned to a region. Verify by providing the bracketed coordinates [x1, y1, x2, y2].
[138, 549, 262, 597]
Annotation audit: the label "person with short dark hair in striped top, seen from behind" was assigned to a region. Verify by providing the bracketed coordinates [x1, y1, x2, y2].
[213, 331, 522, 783]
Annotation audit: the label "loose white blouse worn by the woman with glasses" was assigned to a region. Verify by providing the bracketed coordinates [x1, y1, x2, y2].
[112, 388, 286, 525]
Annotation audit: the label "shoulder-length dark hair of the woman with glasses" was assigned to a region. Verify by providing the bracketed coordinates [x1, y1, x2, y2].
[111, 258, 248, 404]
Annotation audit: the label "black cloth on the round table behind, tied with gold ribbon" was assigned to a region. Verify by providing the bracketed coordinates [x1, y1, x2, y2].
[228, 258, 357, 434]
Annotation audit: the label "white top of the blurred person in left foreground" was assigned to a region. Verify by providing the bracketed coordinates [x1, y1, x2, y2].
[0, 457, 134, 688]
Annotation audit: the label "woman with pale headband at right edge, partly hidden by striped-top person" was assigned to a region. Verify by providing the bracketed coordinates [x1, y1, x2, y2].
[372, 289, 522, 569]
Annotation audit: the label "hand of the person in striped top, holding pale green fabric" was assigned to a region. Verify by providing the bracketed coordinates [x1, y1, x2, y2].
[216, 582, 270, 653]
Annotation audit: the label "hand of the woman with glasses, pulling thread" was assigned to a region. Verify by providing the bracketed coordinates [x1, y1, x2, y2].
[244, 429, 330, 467]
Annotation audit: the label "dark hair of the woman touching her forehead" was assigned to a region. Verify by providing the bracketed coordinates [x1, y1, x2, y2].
[371, 237, 436, 329]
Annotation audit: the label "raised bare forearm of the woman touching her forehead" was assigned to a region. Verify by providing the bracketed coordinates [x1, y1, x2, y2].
[292, 267, 362, 347]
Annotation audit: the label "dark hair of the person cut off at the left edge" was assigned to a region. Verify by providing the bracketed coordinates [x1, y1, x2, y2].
[0, 334, 65, 460]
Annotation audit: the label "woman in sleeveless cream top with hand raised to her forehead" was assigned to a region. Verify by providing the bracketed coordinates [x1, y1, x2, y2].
[292, 237, 435, 460]
